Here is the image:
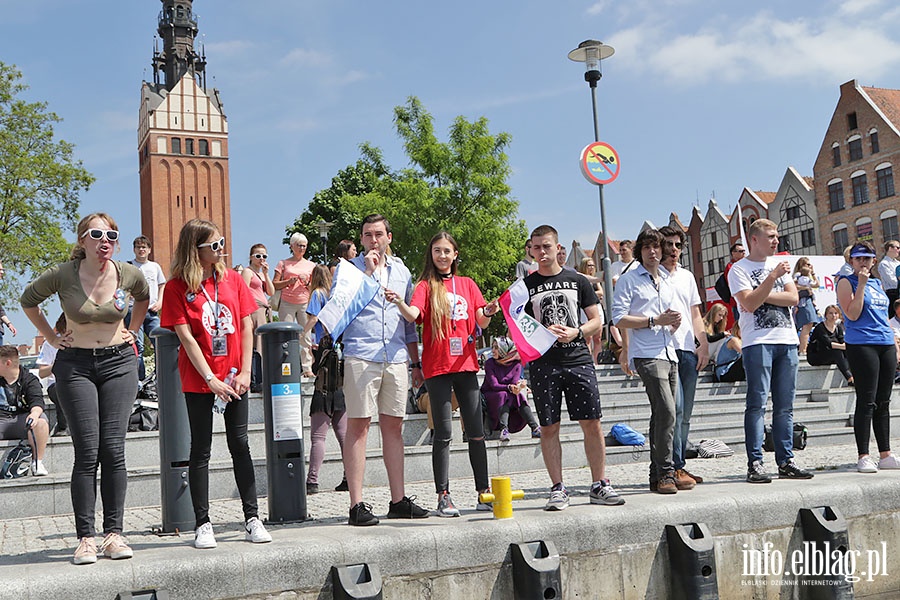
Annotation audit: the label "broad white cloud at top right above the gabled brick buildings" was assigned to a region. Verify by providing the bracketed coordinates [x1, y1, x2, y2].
[609, 7, 900, 85]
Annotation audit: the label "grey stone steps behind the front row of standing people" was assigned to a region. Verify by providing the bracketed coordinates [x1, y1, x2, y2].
[0, 365, 900, 518]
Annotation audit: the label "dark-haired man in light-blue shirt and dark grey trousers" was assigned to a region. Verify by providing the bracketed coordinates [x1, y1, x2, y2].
[612, 229, 695, 494]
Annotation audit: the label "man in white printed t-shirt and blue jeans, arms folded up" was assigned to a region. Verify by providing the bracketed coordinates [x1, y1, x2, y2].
[728, 219, 813, 483]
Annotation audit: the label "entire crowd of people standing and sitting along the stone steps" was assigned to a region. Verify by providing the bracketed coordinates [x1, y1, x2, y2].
[0, 213, 900, 564]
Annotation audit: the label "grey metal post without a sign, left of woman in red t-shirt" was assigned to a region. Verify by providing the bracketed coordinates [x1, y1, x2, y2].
[150, 327, 195, 533]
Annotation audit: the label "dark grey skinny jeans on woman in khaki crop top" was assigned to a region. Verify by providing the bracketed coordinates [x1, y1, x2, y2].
[53, 344, 138, 538]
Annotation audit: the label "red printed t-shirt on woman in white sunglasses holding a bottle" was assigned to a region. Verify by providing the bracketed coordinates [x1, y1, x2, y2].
[160, 269, 257, 394]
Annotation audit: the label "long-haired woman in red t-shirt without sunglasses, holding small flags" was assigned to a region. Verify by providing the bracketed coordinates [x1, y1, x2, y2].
[385, 231, 497, 517]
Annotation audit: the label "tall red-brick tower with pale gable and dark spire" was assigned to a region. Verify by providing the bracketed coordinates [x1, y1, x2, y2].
[137, 0, 231, 275]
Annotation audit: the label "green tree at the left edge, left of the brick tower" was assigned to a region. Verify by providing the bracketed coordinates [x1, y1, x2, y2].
[0, 62, 94, 307]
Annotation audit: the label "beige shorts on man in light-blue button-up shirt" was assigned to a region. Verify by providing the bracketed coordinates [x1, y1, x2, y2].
[344, 356, 409, 419]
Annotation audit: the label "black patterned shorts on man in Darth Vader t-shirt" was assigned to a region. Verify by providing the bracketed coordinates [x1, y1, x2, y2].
[529, 361, 603, 425]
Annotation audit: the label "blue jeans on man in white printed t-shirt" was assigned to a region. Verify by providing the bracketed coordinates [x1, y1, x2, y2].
[743, 344, 798, 466]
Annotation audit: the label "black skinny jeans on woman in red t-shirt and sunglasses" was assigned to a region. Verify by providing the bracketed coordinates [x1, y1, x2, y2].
[184, 392, 259, 527]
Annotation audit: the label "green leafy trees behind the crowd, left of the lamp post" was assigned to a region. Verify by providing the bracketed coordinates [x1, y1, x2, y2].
[288, 97, 527, 312]
